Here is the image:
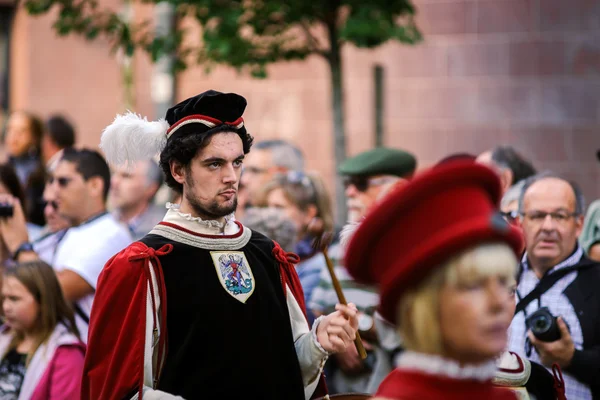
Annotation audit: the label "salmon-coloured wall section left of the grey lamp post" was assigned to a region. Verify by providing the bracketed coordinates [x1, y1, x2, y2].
[9, 0, 152, 147]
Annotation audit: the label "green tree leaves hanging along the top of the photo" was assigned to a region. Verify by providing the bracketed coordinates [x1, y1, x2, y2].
[19, 0, 421, 73]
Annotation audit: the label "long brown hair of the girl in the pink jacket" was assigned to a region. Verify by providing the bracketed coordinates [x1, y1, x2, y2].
[4, 261, 80, 364]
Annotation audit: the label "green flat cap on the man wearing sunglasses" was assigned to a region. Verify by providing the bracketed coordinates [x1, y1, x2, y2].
[338, 147, 417, 177]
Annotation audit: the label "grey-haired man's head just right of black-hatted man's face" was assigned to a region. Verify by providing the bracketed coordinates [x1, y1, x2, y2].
[236, 139, 304, 203]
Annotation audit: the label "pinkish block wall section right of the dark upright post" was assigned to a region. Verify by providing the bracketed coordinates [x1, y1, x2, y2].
[377, 0, 600, 202]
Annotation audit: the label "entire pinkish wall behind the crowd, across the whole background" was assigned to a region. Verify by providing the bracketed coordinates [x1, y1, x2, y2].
[11, 0, 600, 209]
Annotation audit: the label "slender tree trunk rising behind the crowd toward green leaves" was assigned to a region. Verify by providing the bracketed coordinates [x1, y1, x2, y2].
[327, 20, 347, 230]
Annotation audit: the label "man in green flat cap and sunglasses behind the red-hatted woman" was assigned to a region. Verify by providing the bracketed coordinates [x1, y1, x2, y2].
[308, 147, 417, 393]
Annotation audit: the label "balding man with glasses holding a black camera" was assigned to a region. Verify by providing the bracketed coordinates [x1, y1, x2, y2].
[509, 173, 600, 399]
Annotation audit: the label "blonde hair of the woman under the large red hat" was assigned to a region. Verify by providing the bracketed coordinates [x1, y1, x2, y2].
[397, 243, 518, 354]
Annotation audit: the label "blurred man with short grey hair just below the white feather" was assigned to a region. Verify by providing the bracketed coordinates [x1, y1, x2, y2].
[110, 160, 166, 240]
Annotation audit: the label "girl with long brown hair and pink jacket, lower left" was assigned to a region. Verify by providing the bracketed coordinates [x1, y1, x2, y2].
[0, 261, 85, 400]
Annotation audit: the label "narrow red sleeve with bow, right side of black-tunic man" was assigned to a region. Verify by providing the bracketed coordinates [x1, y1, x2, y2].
[273, 242, 328, 399]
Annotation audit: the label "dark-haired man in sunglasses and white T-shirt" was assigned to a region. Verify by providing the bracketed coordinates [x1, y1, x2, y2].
[2, 149, 131, 342]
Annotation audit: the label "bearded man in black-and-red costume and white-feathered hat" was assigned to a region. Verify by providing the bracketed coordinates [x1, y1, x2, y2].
[82, 91, 357, 400]
